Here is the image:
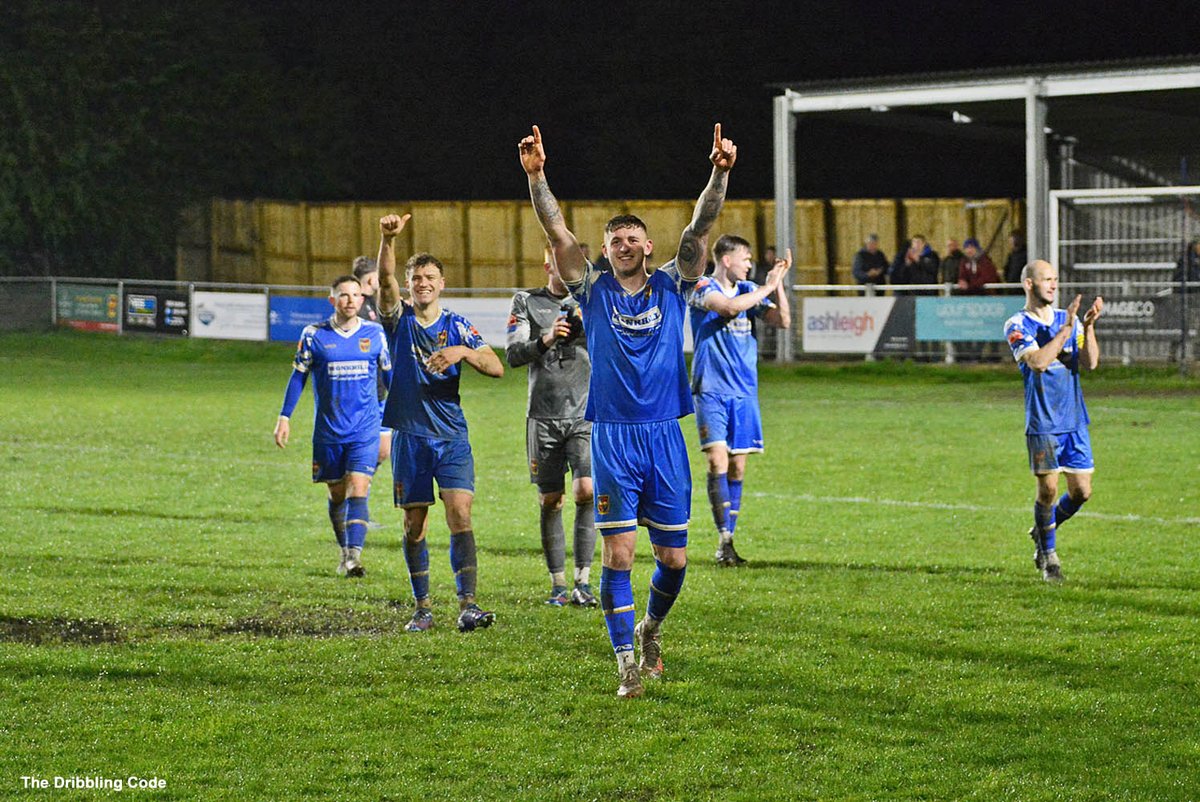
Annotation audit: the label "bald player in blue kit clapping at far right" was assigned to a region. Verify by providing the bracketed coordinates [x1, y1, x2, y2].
[1004, 259, 1104, 582]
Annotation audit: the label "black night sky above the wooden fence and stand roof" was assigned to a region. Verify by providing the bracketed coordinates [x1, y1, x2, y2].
[248, 0, 1200, 199]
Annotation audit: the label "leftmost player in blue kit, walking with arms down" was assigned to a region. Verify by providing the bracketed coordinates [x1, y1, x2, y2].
[275, 276, 391, 576]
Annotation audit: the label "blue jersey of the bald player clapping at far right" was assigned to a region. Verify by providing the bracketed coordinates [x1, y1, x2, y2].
[1004, 309, 1088, 435]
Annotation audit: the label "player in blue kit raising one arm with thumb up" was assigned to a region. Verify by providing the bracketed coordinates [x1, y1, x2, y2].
[378, 215, 504, 632]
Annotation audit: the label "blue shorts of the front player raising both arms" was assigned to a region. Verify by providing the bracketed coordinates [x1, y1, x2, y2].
[592, 420, 691, 547]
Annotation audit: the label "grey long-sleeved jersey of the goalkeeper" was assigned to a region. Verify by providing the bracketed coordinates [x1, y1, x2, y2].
[505, 287, 592, 420]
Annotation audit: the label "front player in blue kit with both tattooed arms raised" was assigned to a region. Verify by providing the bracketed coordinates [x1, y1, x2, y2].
[517, 124, 737, 699]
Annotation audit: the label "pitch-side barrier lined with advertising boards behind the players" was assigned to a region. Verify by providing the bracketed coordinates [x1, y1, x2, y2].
[0, 276, 1200, 367]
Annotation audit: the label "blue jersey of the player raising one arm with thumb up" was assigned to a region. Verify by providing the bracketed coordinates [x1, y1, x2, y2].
[383, 304, 486, 439]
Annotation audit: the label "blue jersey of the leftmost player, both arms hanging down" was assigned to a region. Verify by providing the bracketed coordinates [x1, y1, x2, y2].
[292, 318, 391, 443]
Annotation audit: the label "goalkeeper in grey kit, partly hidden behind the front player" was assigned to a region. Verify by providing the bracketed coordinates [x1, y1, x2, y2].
[506, 250, 598, 608]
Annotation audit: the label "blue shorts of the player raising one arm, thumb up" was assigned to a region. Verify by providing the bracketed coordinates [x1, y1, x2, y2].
[388, 430, 475, 508]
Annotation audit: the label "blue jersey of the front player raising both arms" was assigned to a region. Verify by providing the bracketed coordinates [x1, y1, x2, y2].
[568, 259, 695, 423]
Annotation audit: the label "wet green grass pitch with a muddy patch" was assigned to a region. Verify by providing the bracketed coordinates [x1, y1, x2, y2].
[0, 334, 1200, 800]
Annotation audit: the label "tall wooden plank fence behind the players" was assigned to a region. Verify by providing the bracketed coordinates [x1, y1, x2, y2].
[175, 198, 1024, 287]
